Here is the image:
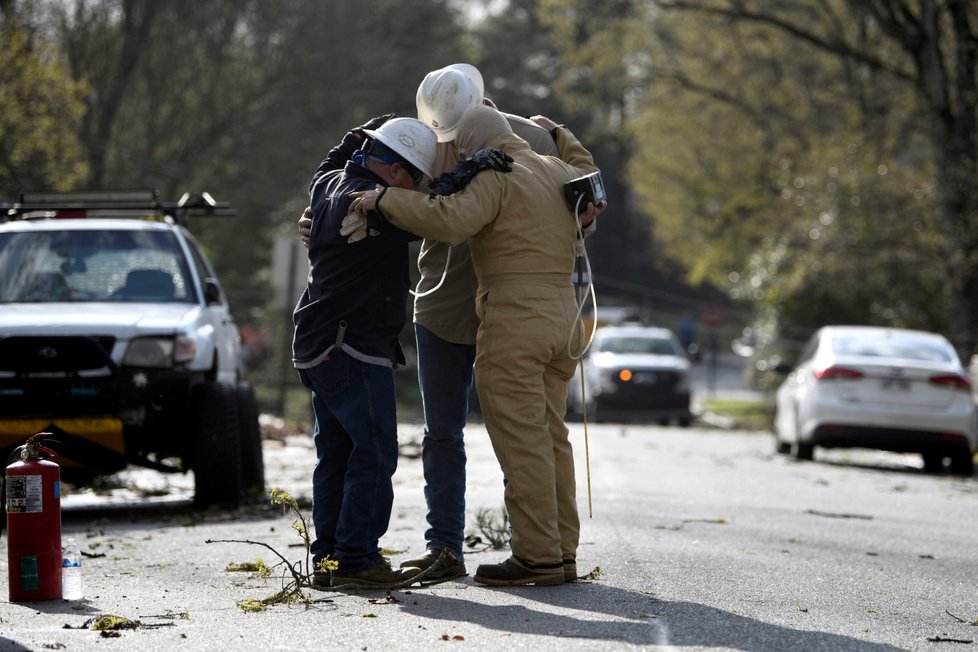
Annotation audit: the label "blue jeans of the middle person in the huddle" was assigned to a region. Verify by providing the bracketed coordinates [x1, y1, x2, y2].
[414, 324, 475, 560]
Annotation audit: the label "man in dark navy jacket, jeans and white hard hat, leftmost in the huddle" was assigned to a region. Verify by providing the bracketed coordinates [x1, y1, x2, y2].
[293, 116, 436, 588]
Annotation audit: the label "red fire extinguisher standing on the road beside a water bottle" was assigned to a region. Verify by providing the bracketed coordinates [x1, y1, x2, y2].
[6, 432, 61, 602]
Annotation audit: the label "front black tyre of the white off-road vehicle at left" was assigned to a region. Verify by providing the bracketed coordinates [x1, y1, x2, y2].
[191, 382, 243, 507]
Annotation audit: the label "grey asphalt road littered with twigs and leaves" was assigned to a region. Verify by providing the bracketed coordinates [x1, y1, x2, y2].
[0, 424, 978, 652]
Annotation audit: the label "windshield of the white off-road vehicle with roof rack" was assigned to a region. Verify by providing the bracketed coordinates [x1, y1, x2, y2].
[0, 230, 196, 303]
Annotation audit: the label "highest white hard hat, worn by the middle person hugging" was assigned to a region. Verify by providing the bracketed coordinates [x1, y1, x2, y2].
[415, 63, 485, 143]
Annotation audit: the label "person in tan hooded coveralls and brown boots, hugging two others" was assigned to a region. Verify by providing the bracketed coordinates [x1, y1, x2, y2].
[351, 106, 597, 586]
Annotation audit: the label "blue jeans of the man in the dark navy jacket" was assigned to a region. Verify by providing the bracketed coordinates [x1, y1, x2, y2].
[298, 349, 397, 573]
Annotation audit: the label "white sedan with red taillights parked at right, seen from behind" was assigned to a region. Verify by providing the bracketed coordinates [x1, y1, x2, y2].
[774, 326, 978, 476]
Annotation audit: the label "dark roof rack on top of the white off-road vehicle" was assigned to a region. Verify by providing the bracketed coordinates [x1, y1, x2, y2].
[0, 190, 238, 225]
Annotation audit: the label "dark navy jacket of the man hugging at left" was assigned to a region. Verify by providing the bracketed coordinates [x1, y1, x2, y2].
[292, 152, 419, 367]
